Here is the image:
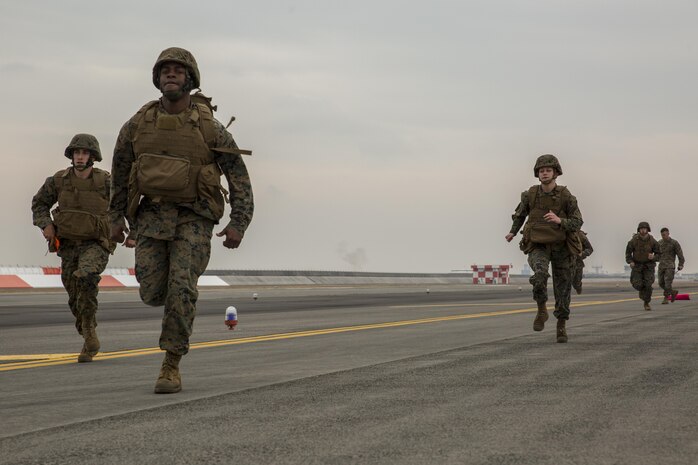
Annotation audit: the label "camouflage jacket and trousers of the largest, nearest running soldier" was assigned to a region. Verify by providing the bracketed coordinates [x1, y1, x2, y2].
[110, 83, 254, 356]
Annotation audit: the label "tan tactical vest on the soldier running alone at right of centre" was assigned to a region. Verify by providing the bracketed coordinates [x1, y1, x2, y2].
[524, 186, 571, 244]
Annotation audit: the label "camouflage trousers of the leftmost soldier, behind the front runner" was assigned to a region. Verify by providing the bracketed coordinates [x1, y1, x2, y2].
[58, 239, 109, 334]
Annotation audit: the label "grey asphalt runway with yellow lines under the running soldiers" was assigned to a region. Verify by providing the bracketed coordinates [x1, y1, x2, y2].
[0, 281, 698, 464]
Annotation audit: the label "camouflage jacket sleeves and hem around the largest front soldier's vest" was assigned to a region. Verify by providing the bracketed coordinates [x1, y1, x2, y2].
[109, 103, 254, 240]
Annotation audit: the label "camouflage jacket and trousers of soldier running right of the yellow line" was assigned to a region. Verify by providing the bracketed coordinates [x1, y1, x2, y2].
[510, 186, 584, 320]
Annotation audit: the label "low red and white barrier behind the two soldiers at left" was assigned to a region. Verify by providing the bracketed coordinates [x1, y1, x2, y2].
[0, 266, 228, 289]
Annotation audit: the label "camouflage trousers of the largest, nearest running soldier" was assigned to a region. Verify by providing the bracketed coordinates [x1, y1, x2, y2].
[136, 219, 213, 355]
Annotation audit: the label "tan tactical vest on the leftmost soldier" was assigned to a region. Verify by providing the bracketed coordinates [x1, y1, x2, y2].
[53, 168, 110, 240]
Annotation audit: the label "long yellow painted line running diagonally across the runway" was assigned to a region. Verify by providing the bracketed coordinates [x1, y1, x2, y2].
[0, 298, 648, 371]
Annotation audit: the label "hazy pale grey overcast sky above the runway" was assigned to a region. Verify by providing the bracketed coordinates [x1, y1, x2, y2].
[0, 0, 698, 272]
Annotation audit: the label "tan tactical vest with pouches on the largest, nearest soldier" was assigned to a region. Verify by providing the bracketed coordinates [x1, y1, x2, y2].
[129, 100, 225, 218]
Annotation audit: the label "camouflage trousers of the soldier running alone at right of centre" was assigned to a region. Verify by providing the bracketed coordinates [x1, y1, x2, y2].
[528, 242, 572, 320]
